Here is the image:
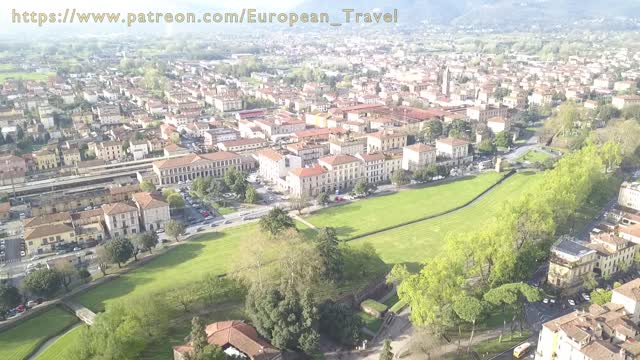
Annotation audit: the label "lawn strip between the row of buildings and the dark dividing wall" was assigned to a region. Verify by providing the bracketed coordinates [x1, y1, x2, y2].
[306, 172, 504, 238]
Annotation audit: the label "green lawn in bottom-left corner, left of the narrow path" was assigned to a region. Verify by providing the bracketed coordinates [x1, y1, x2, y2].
[0, 307, 78, 360]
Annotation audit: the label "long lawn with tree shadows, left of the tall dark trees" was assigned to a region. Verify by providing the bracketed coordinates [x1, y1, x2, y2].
[76, 224, 257, 311]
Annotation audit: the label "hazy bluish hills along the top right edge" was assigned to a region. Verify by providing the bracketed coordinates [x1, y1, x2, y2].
[295, 0, 640, 28]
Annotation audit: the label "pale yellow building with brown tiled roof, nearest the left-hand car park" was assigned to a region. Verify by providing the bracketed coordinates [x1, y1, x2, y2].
[24, 224, 75, 254]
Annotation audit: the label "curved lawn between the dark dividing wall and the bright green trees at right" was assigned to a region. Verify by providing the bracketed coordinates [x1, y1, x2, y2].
[349, 173, 541, 265]
